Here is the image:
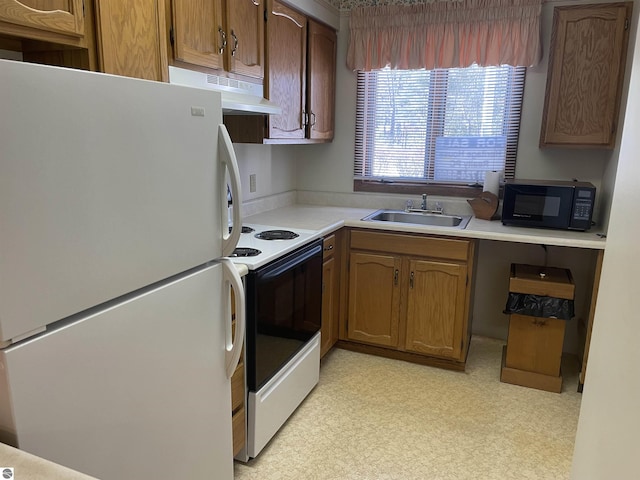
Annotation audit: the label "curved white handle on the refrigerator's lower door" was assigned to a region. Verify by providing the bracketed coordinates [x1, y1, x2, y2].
[220, 258, 246, 378]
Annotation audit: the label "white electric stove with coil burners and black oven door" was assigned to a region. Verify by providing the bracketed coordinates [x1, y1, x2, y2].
[232, 223, 322, 461]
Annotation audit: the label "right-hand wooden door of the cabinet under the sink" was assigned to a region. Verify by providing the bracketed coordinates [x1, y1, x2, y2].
[405, 260, 467, 360]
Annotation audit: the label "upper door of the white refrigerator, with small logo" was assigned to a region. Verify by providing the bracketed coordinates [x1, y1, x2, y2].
[0, 60, 242, 342]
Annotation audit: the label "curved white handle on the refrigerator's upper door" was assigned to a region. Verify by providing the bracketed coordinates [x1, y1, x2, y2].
[218, 124, 242, 257]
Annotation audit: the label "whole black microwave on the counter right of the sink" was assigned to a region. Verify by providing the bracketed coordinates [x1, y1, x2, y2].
[502, 180, 596, 230]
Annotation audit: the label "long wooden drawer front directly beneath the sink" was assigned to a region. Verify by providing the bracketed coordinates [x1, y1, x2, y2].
[351, 230, 470, 261]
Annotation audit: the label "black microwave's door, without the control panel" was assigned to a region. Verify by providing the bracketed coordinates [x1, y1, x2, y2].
[502, 183, 575, 229]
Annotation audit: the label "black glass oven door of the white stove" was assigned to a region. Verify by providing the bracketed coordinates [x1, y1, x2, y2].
[247, 239, 322, 392]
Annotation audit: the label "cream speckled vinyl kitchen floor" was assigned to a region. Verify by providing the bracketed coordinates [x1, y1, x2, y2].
[235, 337, 581, 480]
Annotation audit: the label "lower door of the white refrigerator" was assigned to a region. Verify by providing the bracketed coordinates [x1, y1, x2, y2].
[0, 263, 233, 480]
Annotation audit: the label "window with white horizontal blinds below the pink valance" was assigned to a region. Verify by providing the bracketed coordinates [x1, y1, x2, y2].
[354, 65, 525, 193]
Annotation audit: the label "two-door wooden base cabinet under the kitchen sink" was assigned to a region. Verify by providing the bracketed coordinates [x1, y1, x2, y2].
[342, 230, 476, 369]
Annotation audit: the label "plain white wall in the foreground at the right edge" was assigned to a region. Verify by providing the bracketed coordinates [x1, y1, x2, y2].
[571, 17, 640, 480]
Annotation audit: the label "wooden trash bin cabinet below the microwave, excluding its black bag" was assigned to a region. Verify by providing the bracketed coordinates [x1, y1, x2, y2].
[500, 264, 575, 393]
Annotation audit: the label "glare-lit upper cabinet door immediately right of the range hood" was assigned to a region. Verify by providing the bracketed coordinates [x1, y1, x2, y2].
[265, 0, 307, 139]
